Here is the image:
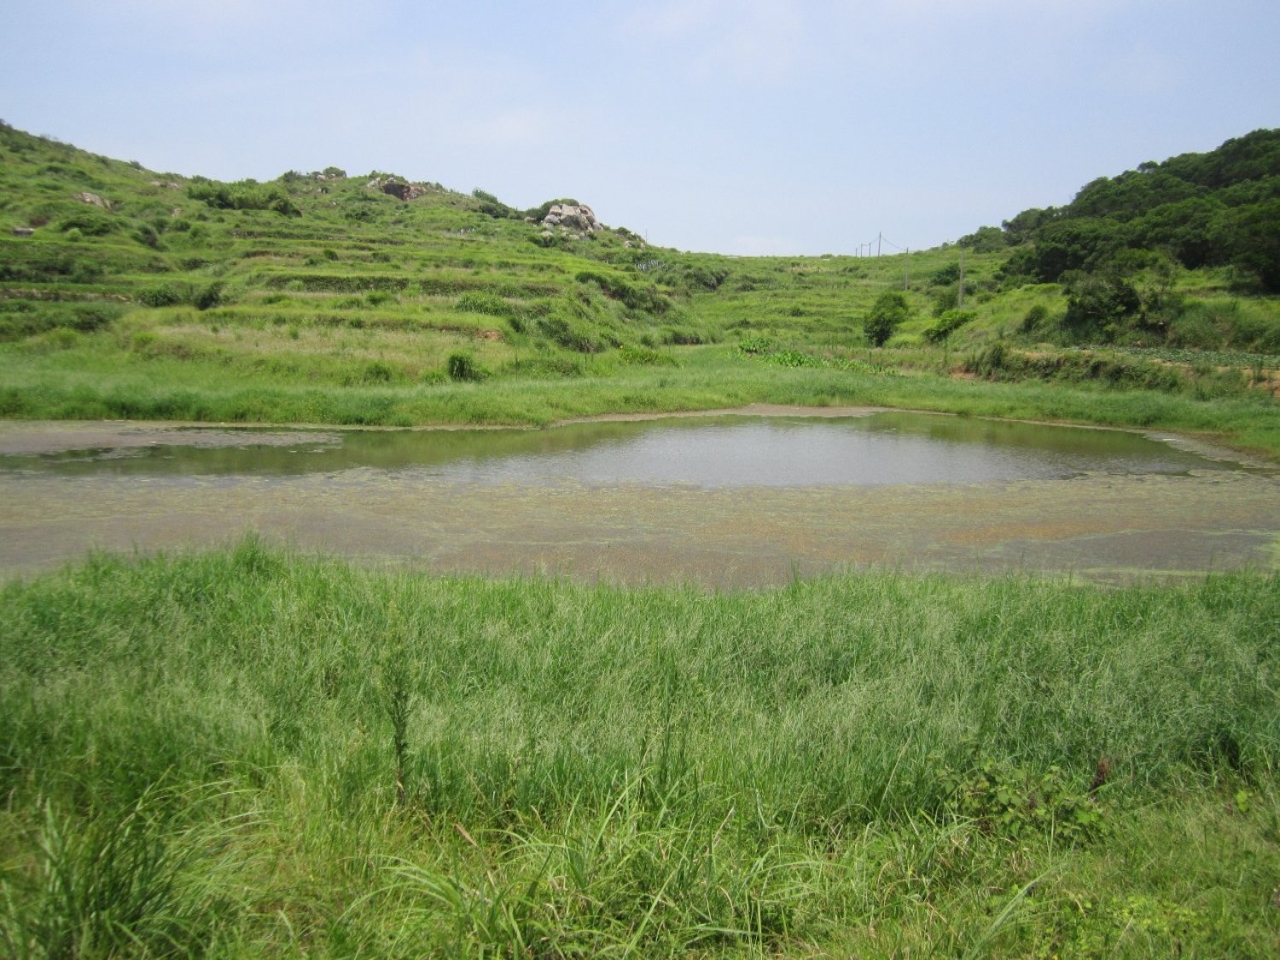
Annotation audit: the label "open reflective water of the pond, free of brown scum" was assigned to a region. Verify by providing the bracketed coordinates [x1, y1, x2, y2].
[0, 412, 1235, 488]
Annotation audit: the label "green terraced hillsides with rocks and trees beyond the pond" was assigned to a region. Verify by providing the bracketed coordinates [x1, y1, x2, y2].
[0, 119, 1280, 449]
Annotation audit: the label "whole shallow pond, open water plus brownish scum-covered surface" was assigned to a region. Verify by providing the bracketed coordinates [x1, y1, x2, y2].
[0, 411, 1280, 586]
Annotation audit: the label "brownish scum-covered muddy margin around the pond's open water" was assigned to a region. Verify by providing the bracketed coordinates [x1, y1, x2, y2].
[0, 406, 1280, 589]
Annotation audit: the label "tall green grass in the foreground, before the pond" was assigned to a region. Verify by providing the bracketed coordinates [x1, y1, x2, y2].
[0, 540, 1280, 957]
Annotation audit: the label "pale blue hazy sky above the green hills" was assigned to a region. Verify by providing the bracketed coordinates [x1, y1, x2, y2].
[0, 0, 1280, 256]
